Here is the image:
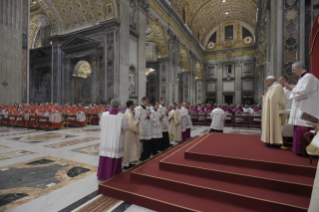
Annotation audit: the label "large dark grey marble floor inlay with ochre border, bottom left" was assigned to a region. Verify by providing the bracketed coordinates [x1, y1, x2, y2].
[0, 156, 97, 211]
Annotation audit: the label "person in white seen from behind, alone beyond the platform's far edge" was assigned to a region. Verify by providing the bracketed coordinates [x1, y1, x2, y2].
[210, 104, 226, 133]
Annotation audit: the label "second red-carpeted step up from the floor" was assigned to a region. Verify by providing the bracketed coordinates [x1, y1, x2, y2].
[131, 135, 311, 211]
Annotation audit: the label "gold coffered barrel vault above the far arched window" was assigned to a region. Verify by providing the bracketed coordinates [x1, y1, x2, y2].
[170, 0, 257, 40]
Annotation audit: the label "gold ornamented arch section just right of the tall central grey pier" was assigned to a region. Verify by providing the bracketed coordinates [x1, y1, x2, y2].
[146, 17, 168, 58]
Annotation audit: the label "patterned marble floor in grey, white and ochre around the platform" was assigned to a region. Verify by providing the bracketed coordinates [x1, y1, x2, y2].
[0, 126, 260, 212]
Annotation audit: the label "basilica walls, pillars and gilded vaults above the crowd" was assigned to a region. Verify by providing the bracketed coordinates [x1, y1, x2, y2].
[0, 0, 318, 104]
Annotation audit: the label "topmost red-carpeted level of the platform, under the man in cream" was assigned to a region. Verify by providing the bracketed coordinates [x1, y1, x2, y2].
[185, 133, 317, 177]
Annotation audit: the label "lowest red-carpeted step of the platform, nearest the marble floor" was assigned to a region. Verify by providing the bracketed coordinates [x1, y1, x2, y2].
[99, 136, 265, 212]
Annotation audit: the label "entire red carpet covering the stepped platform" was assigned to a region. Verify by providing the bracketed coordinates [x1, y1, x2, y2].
[99, 133, 316, 212]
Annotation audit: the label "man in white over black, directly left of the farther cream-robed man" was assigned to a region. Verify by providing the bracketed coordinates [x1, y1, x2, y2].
[158, 97, 170, 151]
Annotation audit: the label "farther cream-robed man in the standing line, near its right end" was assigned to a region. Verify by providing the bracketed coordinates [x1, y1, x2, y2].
[168, 103, 182, 142]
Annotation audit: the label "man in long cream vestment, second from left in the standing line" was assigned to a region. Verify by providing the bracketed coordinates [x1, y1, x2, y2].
[123, 100, 141, 169]
